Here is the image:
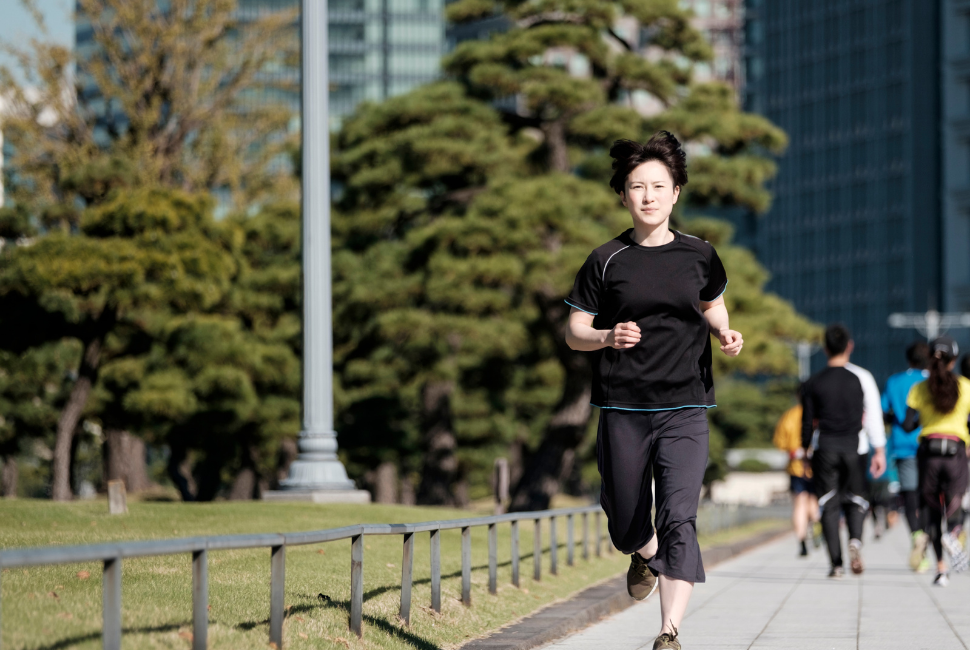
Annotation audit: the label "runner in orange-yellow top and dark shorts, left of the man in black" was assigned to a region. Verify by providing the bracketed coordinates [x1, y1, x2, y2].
[772, 404, 821, 557]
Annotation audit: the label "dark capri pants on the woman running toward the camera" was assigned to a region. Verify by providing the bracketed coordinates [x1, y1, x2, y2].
[596, 407, 710, 582]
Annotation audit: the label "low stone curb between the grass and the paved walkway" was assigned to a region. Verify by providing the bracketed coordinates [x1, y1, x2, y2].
[461, 525, 791, 650]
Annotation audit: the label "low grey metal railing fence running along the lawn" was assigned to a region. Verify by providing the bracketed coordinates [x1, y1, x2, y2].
[0, 505, 774, 650]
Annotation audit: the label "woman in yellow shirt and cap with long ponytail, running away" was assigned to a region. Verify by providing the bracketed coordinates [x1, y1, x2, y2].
[902, 336, 970, 587]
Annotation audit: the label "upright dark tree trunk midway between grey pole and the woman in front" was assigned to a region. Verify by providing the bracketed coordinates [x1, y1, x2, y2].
[417, 382, 460, 506]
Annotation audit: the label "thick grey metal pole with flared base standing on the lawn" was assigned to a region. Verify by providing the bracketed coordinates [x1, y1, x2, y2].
[280, 0, 354, 490]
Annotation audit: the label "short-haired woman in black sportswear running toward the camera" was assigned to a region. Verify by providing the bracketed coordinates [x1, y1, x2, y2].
[566, 131, 743, 650]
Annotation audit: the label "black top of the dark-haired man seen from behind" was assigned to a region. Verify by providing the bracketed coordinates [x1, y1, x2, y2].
[802, 367, 865, 452]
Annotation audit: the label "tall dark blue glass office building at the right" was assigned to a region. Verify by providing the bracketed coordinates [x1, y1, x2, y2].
[745, 0, 944, 381]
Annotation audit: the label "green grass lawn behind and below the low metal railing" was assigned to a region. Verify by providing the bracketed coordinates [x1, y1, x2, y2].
[0, 500, 778, 650]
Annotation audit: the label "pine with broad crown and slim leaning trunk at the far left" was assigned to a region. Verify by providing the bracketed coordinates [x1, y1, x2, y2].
[0, 189, 235, 500]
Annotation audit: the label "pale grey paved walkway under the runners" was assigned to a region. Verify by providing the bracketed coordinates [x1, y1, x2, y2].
[545, 521, 970, 650]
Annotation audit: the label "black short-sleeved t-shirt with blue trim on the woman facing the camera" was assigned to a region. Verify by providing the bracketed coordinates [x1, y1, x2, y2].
[566, 228, 727, 411]
